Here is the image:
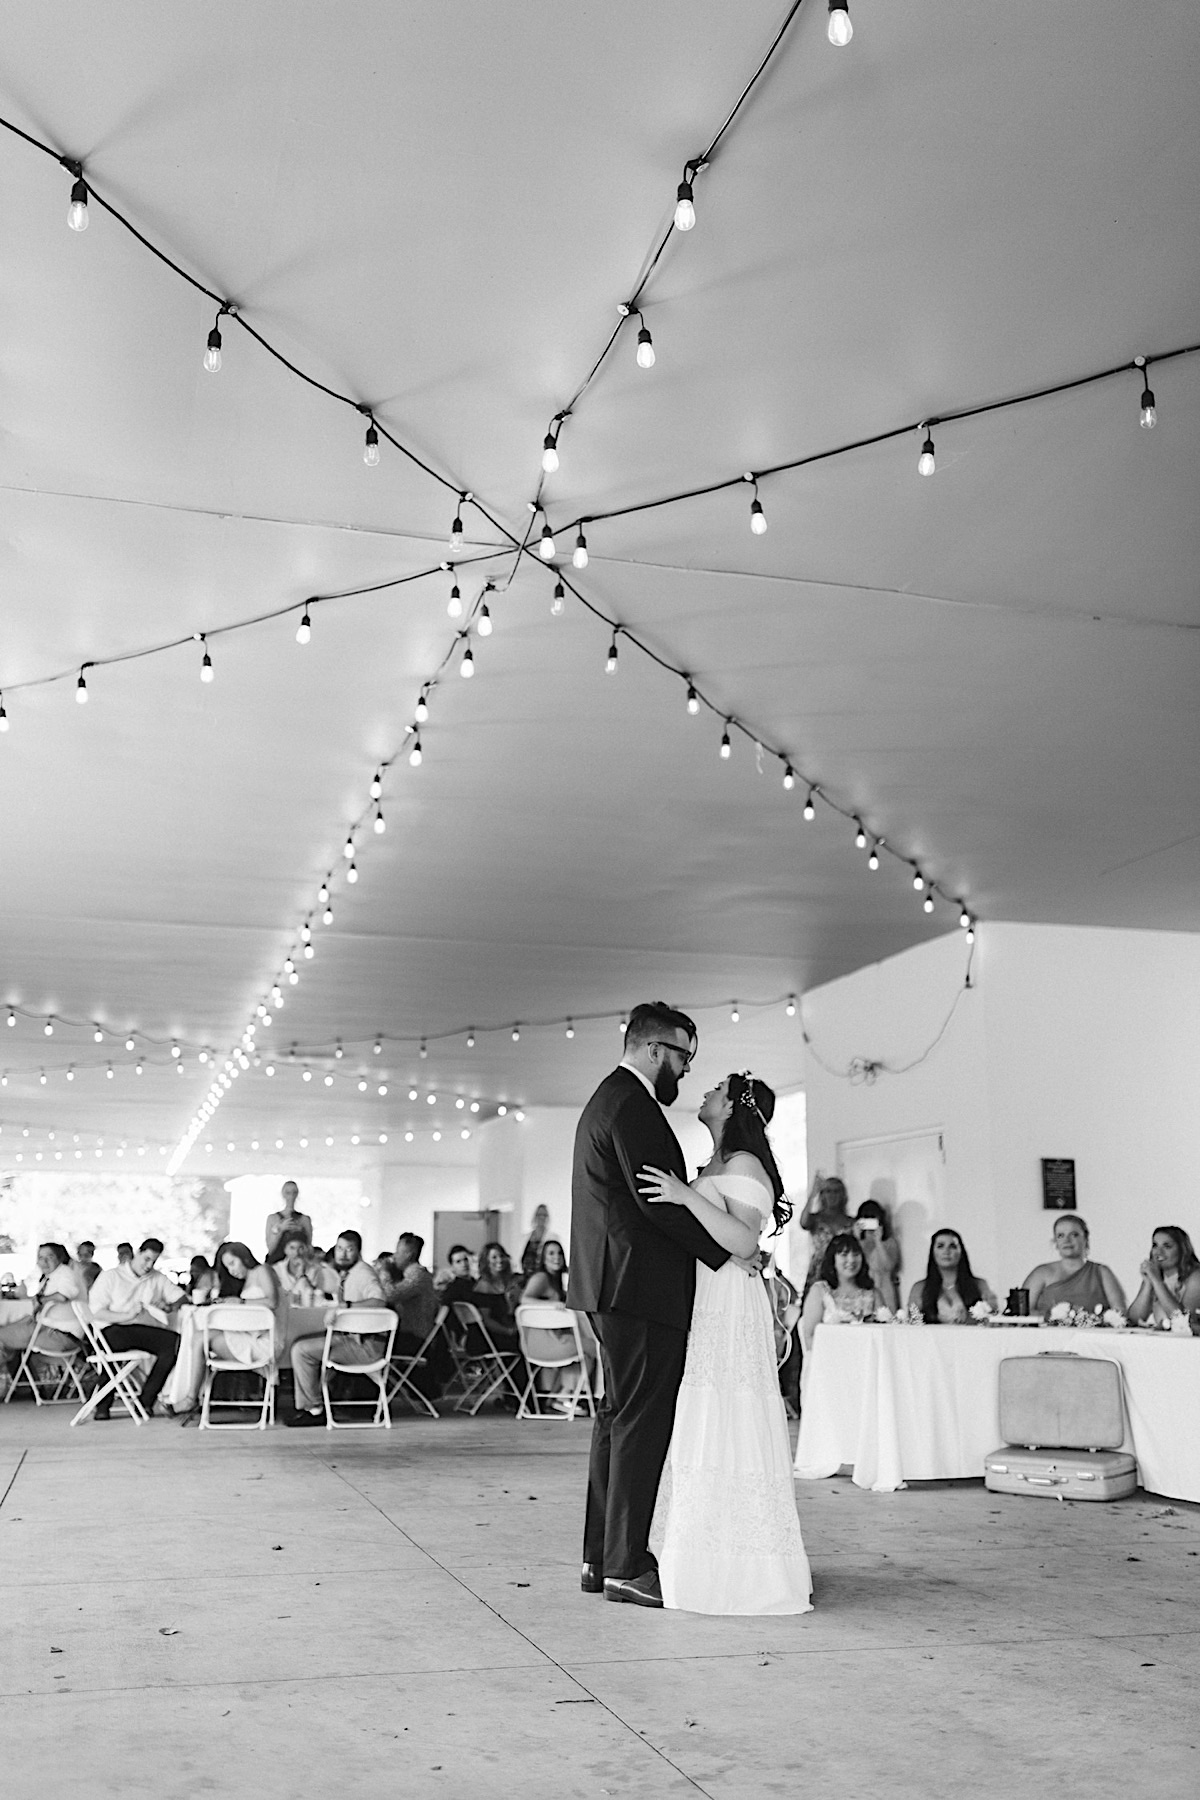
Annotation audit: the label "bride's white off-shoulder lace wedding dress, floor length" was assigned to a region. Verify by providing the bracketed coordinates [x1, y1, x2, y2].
[649, 1175, 813, 1615]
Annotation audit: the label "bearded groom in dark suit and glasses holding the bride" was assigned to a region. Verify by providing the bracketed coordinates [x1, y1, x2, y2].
[570, 1003, 729, 1606]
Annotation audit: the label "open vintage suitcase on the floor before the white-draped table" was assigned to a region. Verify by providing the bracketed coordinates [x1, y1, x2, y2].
[984, 1352, 1137, 1499]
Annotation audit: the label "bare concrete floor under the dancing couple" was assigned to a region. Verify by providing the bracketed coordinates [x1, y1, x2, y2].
[0, 1404, 1200, 1800]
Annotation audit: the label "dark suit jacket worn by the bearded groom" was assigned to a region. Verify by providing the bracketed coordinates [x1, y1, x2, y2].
[570, 1069, 729, 1330]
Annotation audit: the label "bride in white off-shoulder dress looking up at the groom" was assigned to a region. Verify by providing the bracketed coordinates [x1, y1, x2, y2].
[640, 1071, 813, 1613]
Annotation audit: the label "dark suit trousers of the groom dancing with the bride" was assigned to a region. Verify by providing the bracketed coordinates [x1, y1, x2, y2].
[583, 1312, 687, 1580]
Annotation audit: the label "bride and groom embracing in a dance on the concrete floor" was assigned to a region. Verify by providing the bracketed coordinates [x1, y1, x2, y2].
[570, 1004, 811, 1615]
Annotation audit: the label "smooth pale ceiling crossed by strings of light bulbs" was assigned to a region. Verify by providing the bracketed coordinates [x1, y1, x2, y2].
[0, 0, 1200, 1168]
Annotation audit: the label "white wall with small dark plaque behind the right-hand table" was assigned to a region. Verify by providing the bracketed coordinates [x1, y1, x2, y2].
[804, 925, 1200, 1294]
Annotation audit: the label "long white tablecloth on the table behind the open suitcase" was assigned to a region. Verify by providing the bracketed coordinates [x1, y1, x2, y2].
[795, 1325, 1200, 1501]
